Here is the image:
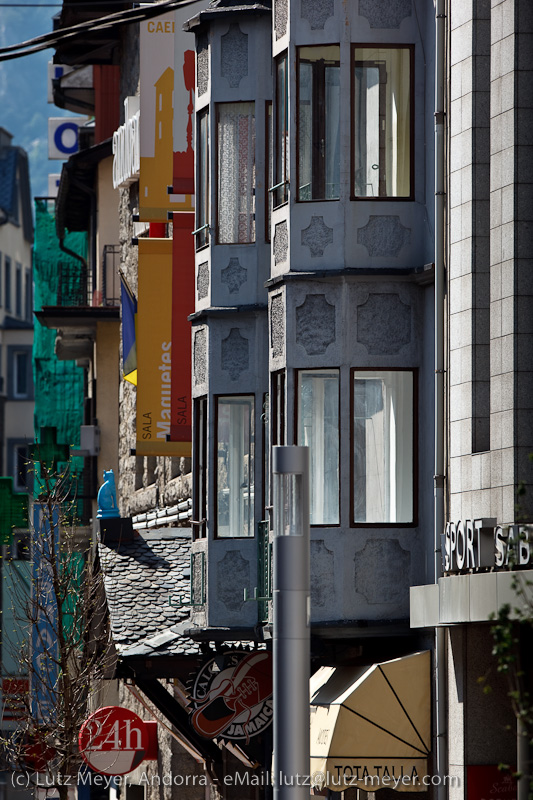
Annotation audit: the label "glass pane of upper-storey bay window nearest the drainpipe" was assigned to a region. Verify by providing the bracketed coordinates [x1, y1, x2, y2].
[353, 47, 411, 197]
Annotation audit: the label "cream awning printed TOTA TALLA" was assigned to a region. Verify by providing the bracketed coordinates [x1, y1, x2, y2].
[311, 651, 431, 792]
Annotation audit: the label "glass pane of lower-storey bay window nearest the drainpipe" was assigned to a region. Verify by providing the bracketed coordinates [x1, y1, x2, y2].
[353, 371, 413, 523]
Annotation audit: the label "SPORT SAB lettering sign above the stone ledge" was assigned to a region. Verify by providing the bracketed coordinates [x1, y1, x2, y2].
[443, 517, 533, 572]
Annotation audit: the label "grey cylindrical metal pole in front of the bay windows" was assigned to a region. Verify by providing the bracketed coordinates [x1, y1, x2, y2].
[272, 447, 310, 800]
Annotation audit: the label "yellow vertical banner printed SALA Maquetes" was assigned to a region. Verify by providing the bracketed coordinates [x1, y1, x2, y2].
[136, 239, 190, 456]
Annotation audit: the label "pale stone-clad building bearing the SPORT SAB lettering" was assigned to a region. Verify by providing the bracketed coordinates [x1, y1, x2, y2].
[411, 0, 532, 797]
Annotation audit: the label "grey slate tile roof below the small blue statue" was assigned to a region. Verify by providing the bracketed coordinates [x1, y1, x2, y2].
[98, 528, 200, 656]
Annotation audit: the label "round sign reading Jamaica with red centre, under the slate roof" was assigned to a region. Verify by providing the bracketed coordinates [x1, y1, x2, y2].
[191, 650, 272, 741]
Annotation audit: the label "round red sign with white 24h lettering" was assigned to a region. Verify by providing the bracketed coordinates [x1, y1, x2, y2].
[78, 706, 157, 775]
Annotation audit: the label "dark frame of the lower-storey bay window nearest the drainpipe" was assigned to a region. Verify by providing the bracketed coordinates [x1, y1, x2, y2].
[350, 366, 419, 528]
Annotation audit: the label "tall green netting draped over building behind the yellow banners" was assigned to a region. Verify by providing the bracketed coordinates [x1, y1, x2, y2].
[33, 199, 87, 500]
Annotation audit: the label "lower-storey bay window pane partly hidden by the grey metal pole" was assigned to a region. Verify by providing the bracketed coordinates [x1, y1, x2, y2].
[298, 369, 339, 525]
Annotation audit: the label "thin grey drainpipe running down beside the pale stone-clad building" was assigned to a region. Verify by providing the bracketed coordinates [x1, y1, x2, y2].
[433, 0, 447, 800]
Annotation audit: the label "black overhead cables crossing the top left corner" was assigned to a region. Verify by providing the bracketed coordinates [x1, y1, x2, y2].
[0, 0, 198, 61]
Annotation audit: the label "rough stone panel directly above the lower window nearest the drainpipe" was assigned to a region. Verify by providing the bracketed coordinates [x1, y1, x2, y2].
[357, 294, 411, 355]
